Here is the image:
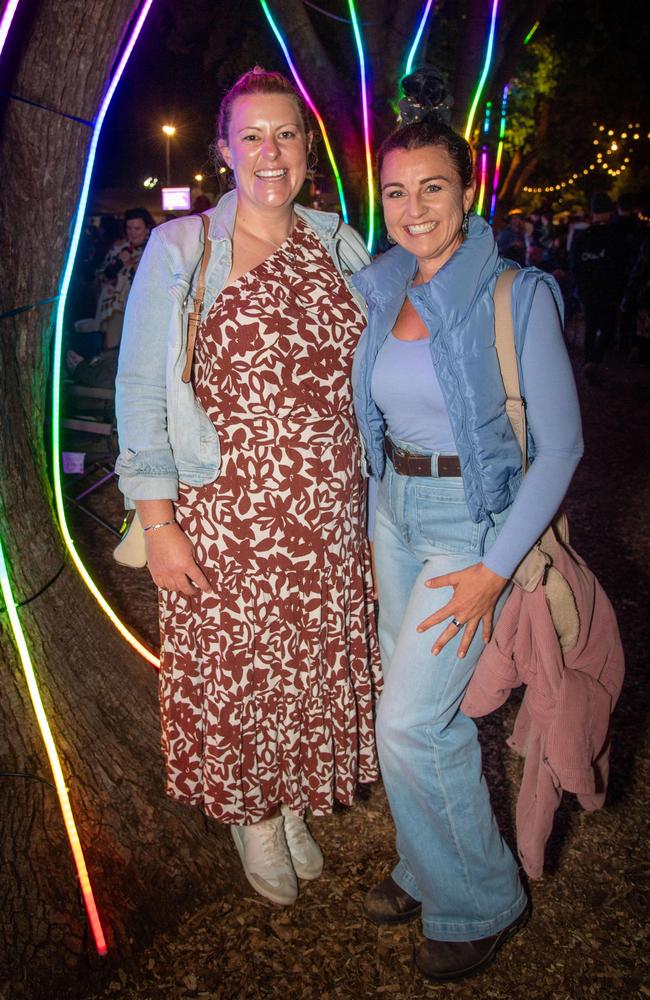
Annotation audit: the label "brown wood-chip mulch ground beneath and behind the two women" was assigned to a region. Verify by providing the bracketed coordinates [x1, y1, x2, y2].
[67, 340, 650, 1000]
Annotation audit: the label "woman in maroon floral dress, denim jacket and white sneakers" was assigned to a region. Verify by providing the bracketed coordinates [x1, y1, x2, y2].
[118, 68, 378, 904]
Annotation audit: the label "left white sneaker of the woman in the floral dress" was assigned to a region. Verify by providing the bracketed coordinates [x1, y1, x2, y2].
[230, 816, 298, 906]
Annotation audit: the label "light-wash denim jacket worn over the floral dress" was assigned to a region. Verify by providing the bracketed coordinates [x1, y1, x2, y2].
[115, 191, 370, 508]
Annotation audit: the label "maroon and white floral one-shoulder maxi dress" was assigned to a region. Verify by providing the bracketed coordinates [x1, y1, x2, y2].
[160, 222, 379, 824]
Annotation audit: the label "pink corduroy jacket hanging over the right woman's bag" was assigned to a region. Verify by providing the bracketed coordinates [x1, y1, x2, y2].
[461, 543, 624, 878]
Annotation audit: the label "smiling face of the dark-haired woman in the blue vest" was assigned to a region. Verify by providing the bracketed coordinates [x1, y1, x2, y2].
[381, 146, 476, 279]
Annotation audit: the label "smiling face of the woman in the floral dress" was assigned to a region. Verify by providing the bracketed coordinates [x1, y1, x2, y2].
[219, 94, 311, 209]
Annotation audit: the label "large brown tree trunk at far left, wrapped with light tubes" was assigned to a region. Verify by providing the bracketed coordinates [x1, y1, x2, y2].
[0, 0, 235, 997]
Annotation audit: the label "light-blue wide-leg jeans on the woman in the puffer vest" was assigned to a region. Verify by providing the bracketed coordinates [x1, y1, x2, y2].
[374, 446, 527, 941]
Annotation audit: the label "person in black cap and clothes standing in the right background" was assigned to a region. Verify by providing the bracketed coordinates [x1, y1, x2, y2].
[571, 192, 625, 383]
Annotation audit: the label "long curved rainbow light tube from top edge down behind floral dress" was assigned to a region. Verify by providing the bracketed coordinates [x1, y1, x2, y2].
[52, 0, 159, 667]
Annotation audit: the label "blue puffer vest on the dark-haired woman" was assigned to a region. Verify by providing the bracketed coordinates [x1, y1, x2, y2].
[352, 216, 563, 522]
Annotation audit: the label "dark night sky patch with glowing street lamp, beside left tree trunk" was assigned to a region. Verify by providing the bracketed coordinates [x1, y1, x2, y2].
[93, 0, 286, 205]
